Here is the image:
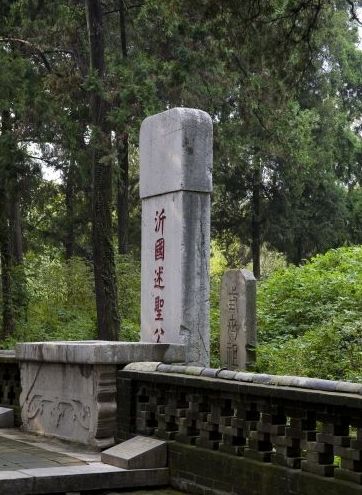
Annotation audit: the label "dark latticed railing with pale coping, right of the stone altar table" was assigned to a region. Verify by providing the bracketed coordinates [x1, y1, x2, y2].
[117, 363, 362, 495]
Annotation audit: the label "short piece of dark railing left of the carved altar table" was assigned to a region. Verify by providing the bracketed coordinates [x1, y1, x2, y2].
[0, 351, 21, 424]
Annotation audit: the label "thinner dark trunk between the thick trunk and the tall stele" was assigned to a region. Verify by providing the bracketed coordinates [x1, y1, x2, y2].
[117, 0, 129, 254]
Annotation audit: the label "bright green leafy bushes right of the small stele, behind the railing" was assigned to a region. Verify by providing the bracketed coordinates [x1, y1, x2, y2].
[258, 246, 362, 381]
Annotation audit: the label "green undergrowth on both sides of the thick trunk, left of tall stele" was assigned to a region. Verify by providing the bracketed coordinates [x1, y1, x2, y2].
[0, 249, 140, 348]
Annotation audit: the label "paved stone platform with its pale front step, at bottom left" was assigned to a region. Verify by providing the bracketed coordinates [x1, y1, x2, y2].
[0, 429, 168, 495]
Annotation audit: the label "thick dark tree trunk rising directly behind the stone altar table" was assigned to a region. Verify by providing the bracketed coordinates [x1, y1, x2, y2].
[85, 0, 119, 340]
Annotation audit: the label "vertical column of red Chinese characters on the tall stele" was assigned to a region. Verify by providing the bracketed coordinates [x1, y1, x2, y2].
[153, 208, 166, 343]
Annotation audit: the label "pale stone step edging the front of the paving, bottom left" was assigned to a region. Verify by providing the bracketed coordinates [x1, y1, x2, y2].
[0, 462, 169, 495]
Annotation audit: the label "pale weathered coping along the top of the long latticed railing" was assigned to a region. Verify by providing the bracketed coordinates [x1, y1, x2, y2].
[124, 362, 362, 395]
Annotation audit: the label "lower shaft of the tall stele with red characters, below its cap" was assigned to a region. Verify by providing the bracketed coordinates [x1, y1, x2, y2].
[141, 191, 210, 364]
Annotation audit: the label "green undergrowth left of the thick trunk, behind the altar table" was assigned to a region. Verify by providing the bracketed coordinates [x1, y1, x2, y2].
[2, 251, 95, 348]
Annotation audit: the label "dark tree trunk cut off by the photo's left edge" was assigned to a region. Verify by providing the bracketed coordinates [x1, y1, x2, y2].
[0, 110, 15, 339]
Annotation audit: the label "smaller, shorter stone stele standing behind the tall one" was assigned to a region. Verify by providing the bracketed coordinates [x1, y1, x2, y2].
[220, 270, 256, 369]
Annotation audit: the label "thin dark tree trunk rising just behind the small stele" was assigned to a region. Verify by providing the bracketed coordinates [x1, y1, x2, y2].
[251, 160, 261, 279]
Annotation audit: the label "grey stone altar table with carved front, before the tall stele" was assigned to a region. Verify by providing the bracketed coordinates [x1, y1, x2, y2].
[16, 341, 185, 449]
